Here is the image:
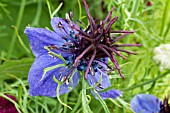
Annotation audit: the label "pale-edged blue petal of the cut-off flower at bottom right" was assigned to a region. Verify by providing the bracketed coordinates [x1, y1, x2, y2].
[130, 94, 161, 113]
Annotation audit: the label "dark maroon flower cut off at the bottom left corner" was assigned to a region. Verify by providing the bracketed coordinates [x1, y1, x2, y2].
[0, 95, 18, 113]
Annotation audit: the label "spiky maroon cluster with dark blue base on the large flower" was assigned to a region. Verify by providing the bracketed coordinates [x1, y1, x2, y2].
[51, 0, 141, 78]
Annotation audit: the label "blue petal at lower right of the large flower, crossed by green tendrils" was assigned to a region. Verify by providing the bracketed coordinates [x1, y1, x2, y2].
[87, 69, 122, 99]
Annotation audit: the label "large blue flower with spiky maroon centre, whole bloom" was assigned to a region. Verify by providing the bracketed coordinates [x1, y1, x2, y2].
[25, 0, 140, 99]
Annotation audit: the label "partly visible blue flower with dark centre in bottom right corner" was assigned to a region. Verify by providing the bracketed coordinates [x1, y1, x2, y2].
[130, 94, 170, 113]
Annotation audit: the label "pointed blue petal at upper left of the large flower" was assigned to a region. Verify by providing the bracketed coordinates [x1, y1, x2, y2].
[24, 27, 65, 56]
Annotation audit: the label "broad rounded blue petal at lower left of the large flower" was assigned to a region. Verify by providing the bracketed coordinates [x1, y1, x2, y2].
[28, 55, 80, 97]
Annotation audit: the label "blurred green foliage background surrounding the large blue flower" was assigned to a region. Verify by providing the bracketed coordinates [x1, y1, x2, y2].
[0, 0, 170, 113]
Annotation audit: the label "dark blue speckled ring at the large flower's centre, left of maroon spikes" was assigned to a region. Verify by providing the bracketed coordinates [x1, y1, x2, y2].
[63, 31, 105, 74]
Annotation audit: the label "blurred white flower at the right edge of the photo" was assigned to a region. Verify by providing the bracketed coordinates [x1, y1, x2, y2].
[153, 44, 170, 71]
